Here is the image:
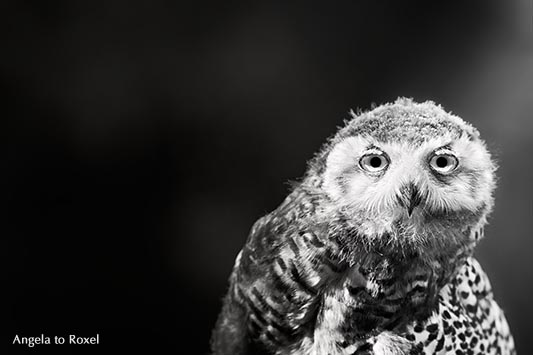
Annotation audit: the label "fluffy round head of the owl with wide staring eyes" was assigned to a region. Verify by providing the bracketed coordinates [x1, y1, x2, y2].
[311, 98, 495, 260]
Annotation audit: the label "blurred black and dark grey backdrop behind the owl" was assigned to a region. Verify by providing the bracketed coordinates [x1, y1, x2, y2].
[5, 0, 533, 354]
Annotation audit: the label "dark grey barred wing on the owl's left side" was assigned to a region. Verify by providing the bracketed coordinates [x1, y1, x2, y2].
[212, 189, 342, 354]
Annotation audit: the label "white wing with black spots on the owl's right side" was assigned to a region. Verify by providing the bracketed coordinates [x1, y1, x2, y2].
[408, 258, 516, 355]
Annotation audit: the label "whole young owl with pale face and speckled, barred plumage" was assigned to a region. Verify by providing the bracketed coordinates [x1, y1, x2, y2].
[211, 98, 515, 355]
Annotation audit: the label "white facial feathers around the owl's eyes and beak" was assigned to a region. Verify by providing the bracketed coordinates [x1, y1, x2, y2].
[323, 134, 495, 235]
